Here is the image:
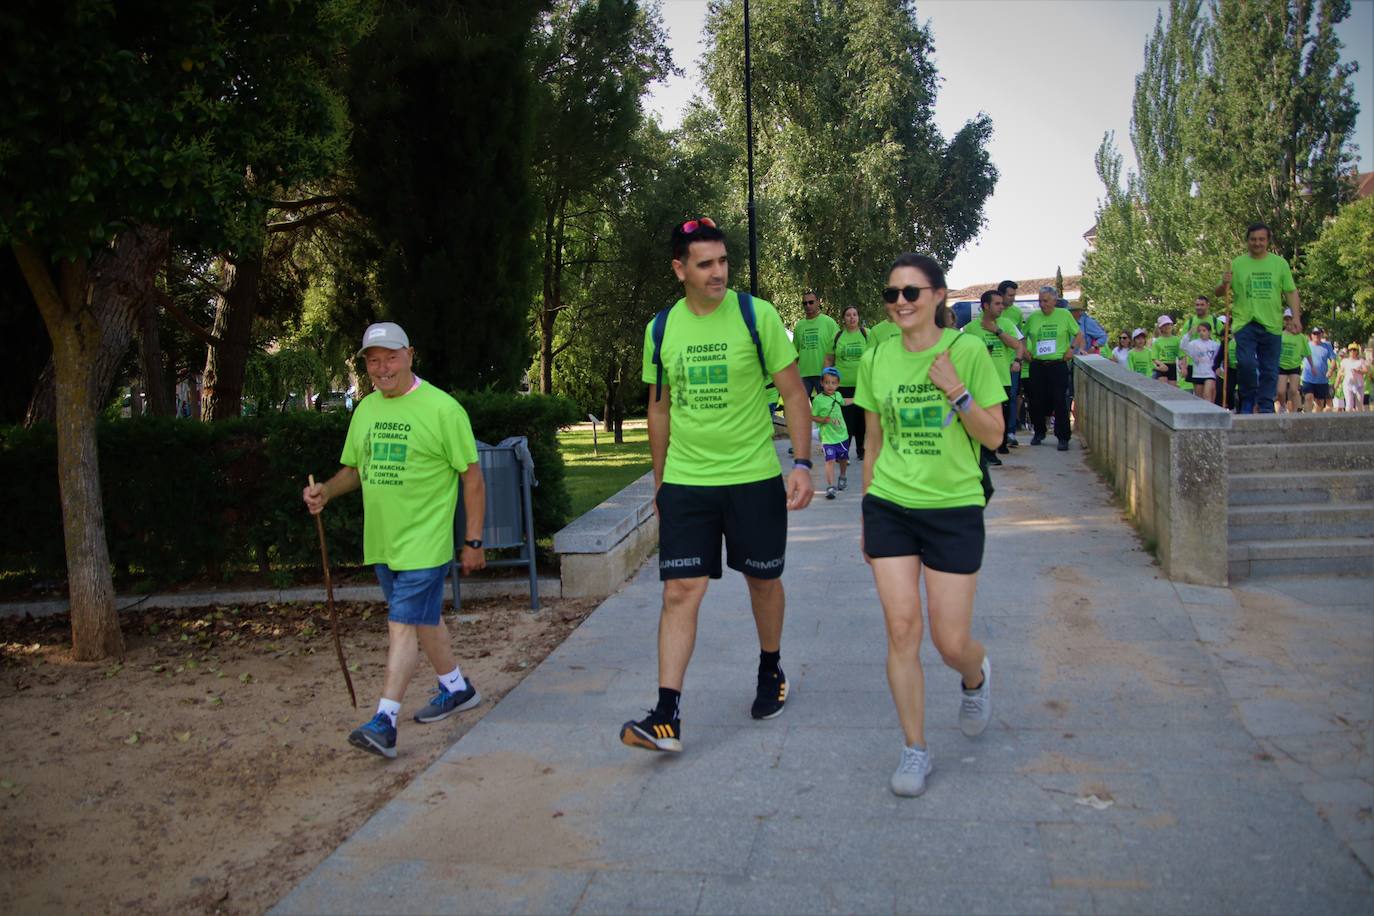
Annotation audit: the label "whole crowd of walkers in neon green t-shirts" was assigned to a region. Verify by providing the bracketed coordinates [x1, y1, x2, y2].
[302, 217, 1371, 797]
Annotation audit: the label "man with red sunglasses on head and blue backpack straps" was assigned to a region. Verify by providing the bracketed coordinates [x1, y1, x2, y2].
[620, 218, 813, 751]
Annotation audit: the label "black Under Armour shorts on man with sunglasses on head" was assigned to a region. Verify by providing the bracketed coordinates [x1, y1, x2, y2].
[658, 475, 787, 580]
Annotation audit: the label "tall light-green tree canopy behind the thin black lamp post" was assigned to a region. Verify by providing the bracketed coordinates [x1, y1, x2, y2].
[705, 0, 998, 317]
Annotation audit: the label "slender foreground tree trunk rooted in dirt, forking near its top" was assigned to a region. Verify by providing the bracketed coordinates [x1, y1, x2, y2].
[14, 243, 124, 662]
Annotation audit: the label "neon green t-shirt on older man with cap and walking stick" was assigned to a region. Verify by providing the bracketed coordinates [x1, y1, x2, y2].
[339, 382, 477, 570]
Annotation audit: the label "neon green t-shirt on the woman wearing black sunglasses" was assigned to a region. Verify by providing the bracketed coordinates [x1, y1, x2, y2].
[855, 328, 1007, 509]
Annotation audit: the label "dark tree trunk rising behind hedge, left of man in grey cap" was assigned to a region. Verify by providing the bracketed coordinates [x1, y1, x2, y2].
[201, 257, 262, 420]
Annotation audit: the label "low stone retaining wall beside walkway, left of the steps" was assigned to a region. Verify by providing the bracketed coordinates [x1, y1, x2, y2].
[1073, 356, 1231, 585]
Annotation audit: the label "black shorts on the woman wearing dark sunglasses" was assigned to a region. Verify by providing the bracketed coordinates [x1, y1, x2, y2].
[863, 493, 984, 575]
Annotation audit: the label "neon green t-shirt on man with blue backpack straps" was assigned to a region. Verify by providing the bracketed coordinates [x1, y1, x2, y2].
[640, 290, 797, 486]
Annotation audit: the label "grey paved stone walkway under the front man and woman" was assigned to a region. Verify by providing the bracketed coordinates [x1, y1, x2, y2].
[276, 442, 1374, 913]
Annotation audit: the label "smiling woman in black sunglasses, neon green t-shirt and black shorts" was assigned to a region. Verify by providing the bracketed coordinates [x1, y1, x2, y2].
[855, 254, 1007, 795]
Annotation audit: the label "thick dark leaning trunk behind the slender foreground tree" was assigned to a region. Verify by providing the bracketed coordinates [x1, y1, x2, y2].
[23, 225, 170, 426]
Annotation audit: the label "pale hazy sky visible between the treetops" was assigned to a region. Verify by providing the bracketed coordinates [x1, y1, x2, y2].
[649, 0, 1374, 287]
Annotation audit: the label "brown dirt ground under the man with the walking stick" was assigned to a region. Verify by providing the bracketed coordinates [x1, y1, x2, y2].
[0, 599, 595, 913]
